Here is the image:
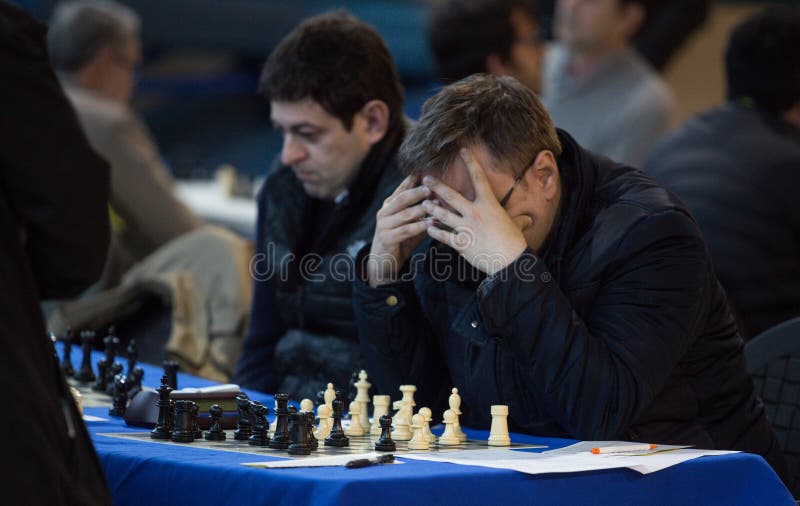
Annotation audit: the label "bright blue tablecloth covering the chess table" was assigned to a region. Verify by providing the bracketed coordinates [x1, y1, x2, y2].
[64, 344, 795, 506]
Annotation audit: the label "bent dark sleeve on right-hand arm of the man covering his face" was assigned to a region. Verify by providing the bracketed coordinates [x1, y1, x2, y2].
[479, 212, 710, 440]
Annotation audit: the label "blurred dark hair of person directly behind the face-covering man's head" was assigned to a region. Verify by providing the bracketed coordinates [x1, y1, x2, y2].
[427, 0, 536, 83]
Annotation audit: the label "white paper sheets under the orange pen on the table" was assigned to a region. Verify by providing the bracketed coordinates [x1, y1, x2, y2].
[402, 442, 736, 474]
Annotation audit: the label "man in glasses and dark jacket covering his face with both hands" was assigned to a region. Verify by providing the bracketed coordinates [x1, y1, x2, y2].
[354, 75, 784, 486]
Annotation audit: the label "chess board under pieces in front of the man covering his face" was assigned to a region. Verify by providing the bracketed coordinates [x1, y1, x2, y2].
[99, 431, 536, 459]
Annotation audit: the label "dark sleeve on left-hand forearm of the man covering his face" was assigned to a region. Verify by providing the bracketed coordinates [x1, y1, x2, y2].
[353, 244, 452, 409]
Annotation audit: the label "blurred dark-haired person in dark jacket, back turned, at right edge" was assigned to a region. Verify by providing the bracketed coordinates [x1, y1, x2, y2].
[645, 7, 800, 337]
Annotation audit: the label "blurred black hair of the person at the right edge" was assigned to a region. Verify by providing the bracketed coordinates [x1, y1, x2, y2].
[725, 7, 800, 114]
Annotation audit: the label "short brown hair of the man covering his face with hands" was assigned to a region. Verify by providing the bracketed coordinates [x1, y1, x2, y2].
[397, 74, 562, 175]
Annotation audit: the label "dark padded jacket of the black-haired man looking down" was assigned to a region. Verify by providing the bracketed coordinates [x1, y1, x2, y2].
[234, 122, 405, 397]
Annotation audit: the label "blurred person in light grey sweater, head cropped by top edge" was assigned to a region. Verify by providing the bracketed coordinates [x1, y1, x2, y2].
[542, 0, 675, 167]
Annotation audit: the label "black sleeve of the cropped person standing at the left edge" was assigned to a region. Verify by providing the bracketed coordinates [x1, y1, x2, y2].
[0, 5, 110, 298]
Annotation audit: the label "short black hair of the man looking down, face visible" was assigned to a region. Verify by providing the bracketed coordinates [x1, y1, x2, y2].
[259, 11, 403, 130]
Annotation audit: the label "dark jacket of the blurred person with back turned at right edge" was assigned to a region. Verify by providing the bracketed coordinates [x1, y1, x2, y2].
[645, 102, 800, 338]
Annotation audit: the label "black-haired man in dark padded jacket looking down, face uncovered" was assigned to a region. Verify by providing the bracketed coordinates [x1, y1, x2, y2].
[235, 13, 406, 398]
